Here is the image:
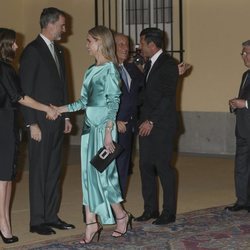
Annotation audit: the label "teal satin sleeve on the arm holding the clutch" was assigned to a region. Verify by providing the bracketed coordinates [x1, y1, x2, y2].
[106, 65, 121, 122]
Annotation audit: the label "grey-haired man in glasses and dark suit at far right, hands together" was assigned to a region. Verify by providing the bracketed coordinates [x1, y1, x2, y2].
[225, 40, 250, 212]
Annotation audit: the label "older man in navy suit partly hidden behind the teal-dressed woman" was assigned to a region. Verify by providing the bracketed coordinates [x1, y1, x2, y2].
[115, 33, 144, 199]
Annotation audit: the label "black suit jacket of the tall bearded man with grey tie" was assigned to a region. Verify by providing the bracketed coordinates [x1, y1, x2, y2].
[20, 35, 67, 128]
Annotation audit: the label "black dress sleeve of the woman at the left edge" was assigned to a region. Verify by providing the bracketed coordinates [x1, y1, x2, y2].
[0, 65, 25, 103]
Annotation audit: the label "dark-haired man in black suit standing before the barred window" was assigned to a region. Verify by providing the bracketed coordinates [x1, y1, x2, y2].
[135, 28, 179, 225]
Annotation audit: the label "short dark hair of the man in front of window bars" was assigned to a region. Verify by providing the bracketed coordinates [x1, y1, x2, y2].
[140, 28, 164, 49]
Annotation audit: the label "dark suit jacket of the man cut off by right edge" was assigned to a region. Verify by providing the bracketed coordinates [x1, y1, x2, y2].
[235, 70, 250, 138]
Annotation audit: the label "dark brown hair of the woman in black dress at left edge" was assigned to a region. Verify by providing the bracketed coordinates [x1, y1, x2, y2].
[0, 28, 16, 61]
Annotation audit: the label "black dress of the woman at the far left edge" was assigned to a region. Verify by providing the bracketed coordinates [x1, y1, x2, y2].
[0, 59, 24, 181]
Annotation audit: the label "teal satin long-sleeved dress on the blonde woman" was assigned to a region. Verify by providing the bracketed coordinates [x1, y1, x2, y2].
[67, 62, 123, 224]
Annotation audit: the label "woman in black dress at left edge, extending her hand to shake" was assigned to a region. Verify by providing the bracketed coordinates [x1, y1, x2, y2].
[0, 28, 57, 243]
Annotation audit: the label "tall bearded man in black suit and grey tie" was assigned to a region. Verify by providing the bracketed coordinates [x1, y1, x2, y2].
[20, 7, 74, 235]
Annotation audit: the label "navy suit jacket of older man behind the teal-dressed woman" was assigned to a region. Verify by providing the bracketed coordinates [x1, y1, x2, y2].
[117, 63, 144, 128]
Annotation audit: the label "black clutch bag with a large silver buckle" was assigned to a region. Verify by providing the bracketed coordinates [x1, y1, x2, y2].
[90, 142, 124, 173]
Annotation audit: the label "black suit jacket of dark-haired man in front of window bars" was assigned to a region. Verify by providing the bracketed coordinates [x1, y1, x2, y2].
[140, 52, 179, 131]
